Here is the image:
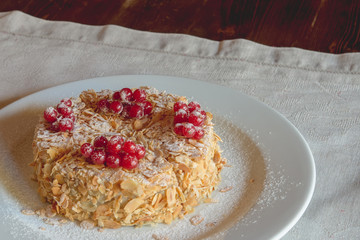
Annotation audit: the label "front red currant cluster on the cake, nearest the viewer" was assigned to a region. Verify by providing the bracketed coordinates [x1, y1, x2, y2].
[80, 135, 146, 169]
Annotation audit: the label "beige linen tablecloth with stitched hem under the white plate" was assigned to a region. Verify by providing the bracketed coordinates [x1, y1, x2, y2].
[0, 11, 360, 240]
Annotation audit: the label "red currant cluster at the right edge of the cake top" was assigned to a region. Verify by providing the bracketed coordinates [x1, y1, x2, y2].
[174, 101, 206, 140]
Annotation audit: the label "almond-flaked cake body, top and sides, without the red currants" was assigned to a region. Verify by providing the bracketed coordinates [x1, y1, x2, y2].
[32, 87, 226, 228]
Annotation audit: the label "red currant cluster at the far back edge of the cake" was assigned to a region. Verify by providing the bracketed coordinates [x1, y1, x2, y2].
[97, 88, 153, 118]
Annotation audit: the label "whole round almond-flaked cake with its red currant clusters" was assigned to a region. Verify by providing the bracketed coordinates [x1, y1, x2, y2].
[32, 87, 225, 228]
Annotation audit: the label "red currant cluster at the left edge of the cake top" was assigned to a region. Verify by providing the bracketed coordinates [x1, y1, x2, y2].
[44, 98, 75, 132]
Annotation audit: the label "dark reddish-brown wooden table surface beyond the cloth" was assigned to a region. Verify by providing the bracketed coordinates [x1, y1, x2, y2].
[0, 0, 360, 53]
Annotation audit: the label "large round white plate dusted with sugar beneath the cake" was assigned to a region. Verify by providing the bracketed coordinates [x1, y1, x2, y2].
[0, 75, 315, 240]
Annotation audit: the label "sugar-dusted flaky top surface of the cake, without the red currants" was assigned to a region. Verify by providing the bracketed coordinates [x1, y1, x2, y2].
[34, 87, 219, 186]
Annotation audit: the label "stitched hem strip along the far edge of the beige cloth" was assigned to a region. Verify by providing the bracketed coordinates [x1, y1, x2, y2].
[0, 11, 360, 74]
